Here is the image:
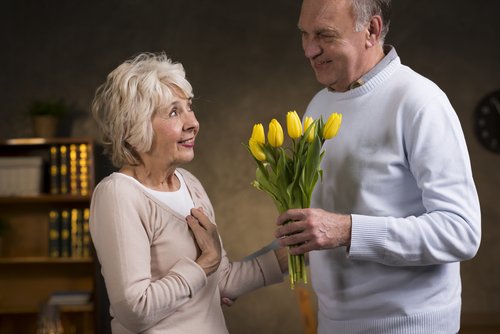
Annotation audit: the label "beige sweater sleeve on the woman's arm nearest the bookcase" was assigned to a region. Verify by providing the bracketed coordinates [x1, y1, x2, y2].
[90, 179, 207, 333]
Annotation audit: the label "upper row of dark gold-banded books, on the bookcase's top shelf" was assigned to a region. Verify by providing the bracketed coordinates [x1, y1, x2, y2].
[50, 143, 92, 196]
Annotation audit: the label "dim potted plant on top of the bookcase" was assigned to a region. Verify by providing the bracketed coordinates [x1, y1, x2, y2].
[28, 100, 68, 138]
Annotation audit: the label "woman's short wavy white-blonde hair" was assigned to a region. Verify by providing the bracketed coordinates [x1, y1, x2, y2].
[92, 52, 193, 168]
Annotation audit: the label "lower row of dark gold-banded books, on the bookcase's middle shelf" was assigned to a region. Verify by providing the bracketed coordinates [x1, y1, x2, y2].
[49, 208, 91, 258]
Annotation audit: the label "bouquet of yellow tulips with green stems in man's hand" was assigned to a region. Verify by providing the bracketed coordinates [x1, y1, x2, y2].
[248, 111, 342, 289]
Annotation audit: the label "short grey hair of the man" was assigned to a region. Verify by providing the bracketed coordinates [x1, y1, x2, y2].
[352, 0, 391, 44]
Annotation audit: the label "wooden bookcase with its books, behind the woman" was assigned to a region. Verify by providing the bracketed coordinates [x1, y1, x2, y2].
[0, 138, 96, 334]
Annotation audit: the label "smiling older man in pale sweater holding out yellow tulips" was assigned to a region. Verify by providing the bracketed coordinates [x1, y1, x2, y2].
[276, 0, 481, 334]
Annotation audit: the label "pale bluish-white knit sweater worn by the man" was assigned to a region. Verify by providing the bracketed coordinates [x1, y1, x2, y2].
[306, 53, 481, 334]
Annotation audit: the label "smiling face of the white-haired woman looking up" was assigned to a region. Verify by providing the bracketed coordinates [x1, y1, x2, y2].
[148, 90, 199, 168]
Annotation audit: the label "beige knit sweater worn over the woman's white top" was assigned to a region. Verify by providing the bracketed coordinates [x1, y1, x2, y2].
[90, 169, 283, 334]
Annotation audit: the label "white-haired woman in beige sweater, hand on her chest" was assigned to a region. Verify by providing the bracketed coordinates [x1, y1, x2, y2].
[90, 53, 287, 334]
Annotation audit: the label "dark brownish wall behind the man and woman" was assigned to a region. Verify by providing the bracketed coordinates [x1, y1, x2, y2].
[0, 0, 500, 334]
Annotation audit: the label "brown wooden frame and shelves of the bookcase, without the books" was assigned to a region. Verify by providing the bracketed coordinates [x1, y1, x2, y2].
[0, 138, 95, 334]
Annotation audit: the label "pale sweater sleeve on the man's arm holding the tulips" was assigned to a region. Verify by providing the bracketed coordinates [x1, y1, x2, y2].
[348, 90, 481, 266]
